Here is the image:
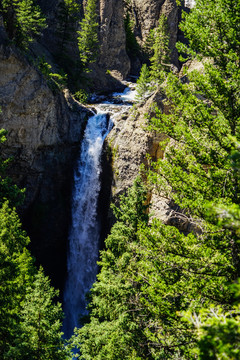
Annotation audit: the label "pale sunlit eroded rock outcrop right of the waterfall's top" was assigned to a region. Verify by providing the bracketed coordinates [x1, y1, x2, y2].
[106, 92, 173, 222]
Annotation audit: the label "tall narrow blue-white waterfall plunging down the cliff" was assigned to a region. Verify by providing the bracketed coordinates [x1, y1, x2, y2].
[63, 113, 110, 338]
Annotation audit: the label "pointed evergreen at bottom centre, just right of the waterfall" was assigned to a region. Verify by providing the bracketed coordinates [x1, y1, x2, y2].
[72, 179, 148, 360]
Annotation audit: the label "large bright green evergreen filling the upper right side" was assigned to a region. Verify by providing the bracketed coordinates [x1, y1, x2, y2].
[149, 0, 240, 262]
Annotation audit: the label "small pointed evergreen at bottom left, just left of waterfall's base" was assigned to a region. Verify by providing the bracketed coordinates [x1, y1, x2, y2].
[13, 268, 68, 360]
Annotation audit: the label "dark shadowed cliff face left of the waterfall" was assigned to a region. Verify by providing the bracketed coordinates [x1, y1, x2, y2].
[0, 22, 89, 286]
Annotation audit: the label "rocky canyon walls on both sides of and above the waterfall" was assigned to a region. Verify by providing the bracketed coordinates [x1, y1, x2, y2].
[0, 0, 193, 289]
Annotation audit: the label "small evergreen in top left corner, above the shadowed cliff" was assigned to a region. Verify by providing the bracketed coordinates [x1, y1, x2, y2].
[0, 0, 46, 50]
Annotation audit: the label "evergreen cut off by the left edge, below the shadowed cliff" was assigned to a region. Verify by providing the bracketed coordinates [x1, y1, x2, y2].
[0, 202, 33, 360]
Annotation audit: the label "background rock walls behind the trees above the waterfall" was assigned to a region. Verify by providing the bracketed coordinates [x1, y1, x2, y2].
[35, 0, 181, 88]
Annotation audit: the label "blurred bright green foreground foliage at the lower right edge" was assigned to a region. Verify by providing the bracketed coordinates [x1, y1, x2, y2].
[185, 143, 240, 360]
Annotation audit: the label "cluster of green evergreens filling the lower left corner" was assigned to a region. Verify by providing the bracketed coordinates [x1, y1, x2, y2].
[0, 130, 72, 360]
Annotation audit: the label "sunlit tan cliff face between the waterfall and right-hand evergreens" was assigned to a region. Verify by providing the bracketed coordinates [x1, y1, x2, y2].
[105, 87, 200, 233]
